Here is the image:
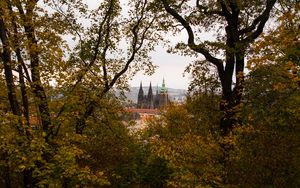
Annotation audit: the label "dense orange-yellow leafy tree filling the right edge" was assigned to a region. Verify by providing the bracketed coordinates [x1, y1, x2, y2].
[228, 1, 300, 187]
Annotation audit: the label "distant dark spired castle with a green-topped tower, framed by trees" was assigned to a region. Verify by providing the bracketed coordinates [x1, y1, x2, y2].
[137, 79, 169, 109]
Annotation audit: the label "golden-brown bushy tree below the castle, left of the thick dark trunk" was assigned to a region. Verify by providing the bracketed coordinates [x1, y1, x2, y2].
[142, 103, 223, 187]
